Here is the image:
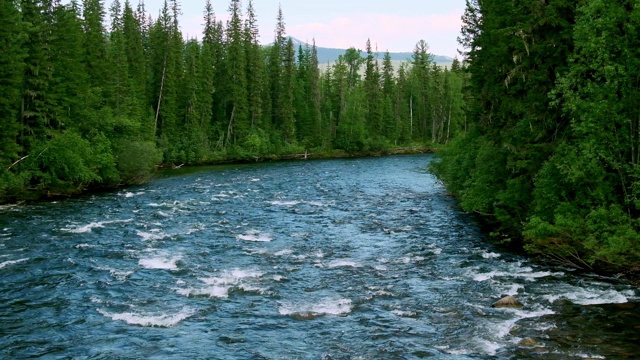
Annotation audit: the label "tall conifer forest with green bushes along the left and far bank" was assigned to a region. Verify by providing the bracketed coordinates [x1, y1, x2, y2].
[0, 0, 466, 203]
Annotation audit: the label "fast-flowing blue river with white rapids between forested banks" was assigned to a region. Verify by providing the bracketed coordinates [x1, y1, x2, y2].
[0, 155, 640, 359]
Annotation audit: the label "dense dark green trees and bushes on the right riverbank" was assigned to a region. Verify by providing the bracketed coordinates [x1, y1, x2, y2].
[434, 0, 640, 271]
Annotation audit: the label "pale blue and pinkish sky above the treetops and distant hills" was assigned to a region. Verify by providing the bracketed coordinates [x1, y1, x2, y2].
[139, 0, 465, 57]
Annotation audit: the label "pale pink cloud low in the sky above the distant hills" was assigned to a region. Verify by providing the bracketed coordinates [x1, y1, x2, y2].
[287, 12, 461, 55]
